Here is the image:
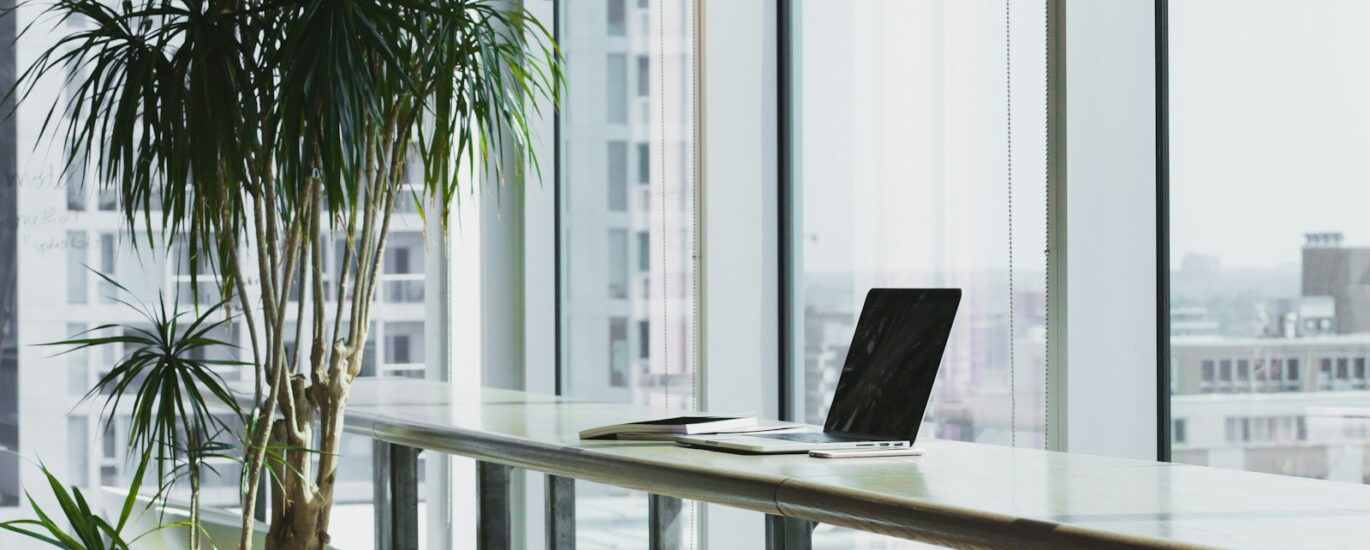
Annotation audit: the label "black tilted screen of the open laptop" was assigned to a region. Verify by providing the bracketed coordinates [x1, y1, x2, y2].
[823, 288, 960, 442]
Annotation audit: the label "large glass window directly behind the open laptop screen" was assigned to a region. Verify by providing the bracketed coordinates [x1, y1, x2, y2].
[788, 0, 1047, 547]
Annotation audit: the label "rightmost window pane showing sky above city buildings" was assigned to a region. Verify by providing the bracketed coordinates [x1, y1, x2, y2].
[1169, 0, 1370, 483]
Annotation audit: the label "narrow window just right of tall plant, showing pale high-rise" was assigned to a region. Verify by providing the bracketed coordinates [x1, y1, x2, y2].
[558, 0, 696, 547]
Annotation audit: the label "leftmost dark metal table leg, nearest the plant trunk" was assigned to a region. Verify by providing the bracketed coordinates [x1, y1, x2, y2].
[371, 440, 419, 550]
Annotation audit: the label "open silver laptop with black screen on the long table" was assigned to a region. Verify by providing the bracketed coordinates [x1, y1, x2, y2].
[675, 288, 960, 454]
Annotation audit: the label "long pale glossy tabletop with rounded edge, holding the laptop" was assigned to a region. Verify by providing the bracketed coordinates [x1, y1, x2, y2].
[337, 379, 1370, 549]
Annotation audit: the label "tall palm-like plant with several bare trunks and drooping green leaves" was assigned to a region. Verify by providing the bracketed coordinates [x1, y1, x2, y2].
[12, 0, 562, 549]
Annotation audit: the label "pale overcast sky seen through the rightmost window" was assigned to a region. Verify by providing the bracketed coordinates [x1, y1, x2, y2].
[1170, 0, 1370, 267]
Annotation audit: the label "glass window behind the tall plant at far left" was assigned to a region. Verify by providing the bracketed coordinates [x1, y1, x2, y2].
[0, 1, 443, 534]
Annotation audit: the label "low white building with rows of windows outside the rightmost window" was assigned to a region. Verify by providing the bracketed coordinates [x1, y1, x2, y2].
[1171, 333, 1370, 483]
